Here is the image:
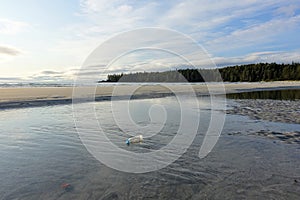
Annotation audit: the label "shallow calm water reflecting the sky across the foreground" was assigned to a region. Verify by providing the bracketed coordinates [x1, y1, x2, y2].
[0, 97, 300, 199]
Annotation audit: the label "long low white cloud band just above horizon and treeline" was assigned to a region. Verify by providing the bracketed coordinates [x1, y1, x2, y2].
[15, 50, 300, 84]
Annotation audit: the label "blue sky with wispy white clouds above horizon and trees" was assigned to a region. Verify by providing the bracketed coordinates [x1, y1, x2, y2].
[0, 0, 300, 82]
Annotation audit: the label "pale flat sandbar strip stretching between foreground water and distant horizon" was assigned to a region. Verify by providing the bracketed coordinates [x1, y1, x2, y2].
[0, 81, 300, 110]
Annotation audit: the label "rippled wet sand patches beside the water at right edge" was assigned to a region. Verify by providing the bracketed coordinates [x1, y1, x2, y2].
[226, 99, 300, 144]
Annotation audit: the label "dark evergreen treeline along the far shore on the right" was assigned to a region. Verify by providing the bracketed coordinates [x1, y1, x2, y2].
[107, 63, 300, 82]
